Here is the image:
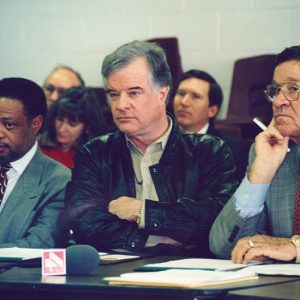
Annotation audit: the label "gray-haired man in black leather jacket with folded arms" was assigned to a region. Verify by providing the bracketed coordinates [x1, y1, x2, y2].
[66, 41, 236, 257]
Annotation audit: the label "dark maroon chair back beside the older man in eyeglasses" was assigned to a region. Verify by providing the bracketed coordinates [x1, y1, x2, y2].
[215, 54, 276, 140]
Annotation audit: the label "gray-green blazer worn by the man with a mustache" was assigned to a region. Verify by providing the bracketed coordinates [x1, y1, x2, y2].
[0, 149, 70, 248]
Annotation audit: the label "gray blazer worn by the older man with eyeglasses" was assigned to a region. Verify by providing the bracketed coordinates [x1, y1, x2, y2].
[209, 144, 299, 258]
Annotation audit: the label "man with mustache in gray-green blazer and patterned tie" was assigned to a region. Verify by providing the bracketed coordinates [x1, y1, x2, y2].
[0, 78, 70, 248]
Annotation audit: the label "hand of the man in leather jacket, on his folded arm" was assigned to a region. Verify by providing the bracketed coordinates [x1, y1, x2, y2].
[108, 196, 142, 221]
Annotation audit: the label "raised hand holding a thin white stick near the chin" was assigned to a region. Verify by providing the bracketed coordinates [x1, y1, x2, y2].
[248, 121, 289, 184]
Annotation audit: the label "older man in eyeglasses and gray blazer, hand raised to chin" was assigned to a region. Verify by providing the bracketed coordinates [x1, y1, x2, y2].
[210, 46, 300, 263]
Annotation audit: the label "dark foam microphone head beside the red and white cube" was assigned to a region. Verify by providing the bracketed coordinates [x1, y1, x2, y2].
[66, 245, 100, 275]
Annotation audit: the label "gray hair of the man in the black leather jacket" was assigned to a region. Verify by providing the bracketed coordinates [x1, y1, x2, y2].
[102, 41, 172, 103]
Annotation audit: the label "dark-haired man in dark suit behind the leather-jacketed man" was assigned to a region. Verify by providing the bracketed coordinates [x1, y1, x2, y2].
[173, 70, 250, 181]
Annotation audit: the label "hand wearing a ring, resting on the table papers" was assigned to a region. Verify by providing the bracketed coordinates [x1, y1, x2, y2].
[231, 235, 296, 264]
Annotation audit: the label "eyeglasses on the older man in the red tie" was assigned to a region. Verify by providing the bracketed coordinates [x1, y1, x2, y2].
[265, 82, 300, 102]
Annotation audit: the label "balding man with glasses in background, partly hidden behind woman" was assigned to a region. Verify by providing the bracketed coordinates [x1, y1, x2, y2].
[43, 65, 85, 107]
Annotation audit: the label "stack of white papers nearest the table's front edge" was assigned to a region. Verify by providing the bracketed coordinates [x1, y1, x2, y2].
[104, 269, 258, 288]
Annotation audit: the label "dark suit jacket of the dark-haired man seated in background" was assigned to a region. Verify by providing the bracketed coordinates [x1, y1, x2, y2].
[207, 125, 251, 182]
